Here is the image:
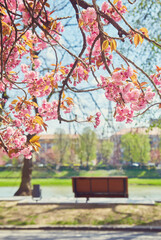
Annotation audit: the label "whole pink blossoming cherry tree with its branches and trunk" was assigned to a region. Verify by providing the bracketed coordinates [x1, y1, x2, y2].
[0, 0, 161, 194]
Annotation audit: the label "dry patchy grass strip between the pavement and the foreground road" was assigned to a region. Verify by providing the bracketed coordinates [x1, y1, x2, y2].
[0, 201, 161, 226]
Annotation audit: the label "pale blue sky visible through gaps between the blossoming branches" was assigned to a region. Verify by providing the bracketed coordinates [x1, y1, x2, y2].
[4, 0, 161, 136]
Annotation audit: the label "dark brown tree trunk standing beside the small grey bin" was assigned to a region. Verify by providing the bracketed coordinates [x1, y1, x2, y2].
[14, 158, 32, 196]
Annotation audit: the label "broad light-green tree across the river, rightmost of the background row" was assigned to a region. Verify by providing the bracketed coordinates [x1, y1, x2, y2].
[121, 133, 150, 165]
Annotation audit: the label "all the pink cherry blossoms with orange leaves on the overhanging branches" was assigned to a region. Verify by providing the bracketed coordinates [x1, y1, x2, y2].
[0, 0, 161, 161]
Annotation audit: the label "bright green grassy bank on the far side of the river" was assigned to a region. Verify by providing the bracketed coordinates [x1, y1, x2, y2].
[0, 169, 161, 187]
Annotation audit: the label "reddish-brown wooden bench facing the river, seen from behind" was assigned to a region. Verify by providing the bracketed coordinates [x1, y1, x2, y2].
[72, 177, 128, 201]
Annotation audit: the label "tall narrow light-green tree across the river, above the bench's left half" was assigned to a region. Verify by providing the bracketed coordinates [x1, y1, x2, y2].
[78, 127, 97, 167]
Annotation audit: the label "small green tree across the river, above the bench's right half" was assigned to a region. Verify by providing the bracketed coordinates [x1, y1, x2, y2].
[98, 140, 114, 164]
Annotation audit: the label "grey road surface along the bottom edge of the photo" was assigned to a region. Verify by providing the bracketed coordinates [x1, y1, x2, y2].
[0, 230, 161, 240]
